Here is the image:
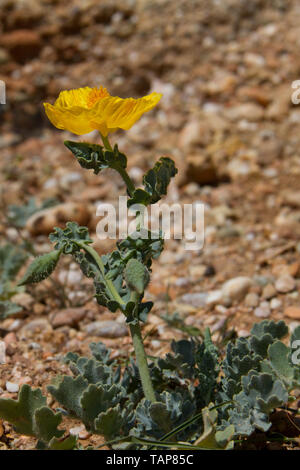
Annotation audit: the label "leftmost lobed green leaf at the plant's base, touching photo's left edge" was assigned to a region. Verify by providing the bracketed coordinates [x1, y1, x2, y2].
[0, 384, 46, 436]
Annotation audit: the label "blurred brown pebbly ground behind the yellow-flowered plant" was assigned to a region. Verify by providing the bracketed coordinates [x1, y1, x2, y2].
[0, 0, 300, 448]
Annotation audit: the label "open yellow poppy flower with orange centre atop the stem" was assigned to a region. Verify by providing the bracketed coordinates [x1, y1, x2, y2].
[44, 87, 162, 137]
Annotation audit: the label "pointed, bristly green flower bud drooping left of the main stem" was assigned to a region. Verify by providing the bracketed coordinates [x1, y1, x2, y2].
[19, 250, 61, 286]
